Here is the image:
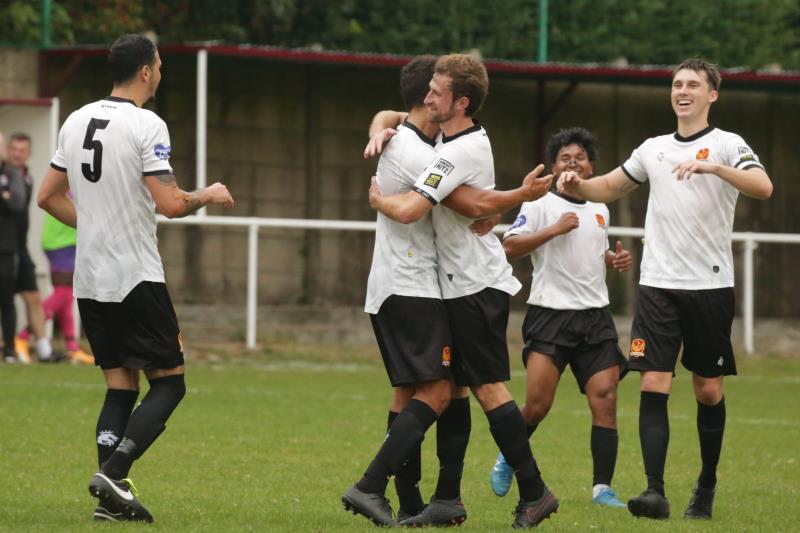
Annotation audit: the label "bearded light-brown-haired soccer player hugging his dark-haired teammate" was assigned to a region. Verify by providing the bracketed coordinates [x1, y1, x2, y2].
[370, 54, 558, 528]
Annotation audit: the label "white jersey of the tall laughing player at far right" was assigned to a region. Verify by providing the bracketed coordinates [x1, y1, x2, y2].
[622, 127, 764, 290]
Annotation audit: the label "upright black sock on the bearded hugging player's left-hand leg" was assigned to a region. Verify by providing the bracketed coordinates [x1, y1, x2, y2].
[433, 398, 472, 500]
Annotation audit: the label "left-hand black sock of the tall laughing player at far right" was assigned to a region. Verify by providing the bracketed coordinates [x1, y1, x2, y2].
[639, 391, 669, 496]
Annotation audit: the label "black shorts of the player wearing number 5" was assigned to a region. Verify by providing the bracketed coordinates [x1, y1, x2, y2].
[78, 281, 183, 370]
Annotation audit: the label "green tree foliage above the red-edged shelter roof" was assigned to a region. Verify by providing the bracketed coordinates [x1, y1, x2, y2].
[0, 0, 800, 69]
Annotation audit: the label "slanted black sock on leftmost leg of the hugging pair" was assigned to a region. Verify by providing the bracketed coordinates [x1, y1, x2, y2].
[356, 398, 436, 494]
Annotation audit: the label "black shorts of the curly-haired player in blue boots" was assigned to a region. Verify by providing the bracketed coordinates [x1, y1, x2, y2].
[522, 305, 628, 394]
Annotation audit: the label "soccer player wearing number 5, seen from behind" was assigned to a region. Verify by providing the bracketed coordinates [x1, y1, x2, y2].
[38, 35, 233, 522]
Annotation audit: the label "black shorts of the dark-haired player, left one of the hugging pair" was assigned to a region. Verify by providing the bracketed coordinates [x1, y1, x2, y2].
[369, 294, 453, 387]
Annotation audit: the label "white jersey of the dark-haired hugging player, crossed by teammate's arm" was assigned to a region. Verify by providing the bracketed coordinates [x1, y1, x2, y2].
[364, 123, 442, 314]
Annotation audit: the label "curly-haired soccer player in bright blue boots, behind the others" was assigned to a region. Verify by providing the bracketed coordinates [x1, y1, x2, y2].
[491, 128, 633, 507]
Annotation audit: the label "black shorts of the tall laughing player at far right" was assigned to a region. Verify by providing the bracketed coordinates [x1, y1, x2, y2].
[629, 285, 736, 378]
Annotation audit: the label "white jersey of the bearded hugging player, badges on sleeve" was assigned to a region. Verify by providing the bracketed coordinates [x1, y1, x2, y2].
[414, 123, 522, 300]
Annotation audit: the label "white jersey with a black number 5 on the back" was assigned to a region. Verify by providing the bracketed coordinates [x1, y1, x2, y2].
[50, 97, 172, 302]
